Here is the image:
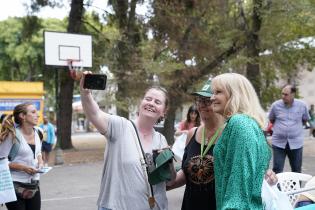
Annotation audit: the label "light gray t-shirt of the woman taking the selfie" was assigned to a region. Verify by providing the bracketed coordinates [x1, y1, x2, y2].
[97, 115, 168, 210]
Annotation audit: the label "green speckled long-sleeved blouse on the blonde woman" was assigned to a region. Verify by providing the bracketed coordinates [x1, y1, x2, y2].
[214, 114, 271, 210]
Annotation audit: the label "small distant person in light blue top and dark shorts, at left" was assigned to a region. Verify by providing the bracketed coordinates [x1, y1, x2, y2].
[39, 116, 56, 166]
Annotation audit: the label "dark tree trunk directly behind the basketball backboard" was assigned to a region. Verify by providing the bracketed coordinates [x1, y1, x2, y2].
[57, 0, 83, 149]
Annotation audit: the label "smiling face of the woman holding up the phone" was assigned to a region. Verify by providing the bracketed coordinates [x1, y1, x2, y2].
[139, 88, 166, 121]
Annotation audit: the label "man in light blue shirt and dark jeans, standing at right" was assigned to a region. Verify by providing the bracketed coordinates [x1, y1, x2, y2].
[269, 85, 309, 173]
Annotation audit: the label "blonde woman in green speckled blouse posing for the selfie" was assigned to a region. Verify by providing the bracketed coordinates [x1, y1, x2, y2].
[211, 73, 271, 210]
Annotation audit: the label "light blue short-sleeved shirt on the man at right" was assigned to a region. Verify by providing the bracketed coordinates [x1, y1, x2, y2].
[269, 99, 309, 149]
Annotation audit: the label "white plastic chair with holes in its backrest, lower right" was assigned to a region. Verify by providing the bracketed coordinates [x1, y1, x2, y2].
[277, 172, 313, 207]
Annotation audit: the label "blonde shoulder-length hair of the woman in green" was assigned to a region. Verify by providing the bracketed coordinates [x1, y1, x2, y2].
[211, 73, 266, 129]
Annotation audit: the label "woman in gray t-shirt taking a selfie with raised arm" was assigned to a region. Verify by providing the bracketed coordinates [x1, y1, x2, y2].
[80, 73, 176, 210]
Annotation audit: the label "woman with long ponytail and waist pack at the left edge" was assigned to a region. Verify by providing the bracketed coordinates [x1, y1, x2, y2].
[0, 102, 43, 210]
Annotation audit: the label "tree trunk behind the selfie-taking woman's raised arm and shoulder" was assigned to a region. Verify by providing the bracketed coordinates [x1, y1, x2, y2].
[112, 0, 141, 118]
